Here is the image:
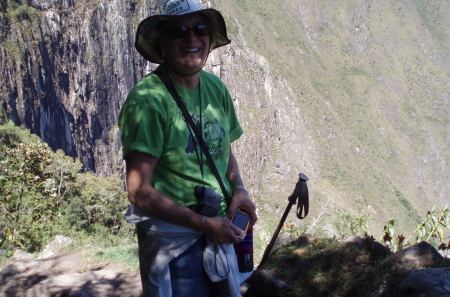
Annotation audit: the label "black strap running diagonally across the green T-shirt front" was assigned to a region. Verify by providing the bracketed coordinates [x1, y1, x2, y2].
[153, 69, 231, 205]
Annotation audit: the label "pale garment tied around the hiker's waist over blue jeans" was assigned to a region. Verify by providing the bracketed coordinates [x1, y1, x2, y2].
[125, 206, 253, 297]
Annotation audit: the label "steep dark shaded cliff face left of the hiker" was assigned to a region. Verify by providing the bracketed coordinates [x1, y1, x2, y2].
[0, 0, 150, 174]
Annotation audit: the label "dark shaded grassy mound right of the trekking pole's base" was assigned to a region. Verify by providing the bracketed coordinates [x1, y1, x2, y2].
[264, 236, 449, 297]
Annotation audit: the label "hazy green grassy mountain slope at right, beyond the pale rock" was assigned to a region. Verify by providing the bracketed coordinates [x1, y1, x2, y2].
[214, 1, 449, 238]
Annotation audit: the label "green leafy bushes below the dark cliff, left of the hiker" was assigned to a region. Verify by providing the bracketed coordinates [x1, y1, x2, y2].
[0, 123, 133, 252]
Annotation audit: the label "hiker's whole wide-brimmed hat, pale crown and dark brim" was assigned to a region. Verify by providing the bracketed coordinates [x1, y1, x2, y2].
[135, 0, 231, 64]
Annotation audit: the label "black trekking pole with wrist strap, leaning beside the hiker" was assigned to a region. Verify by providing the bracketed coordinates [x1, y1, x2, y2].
[258, 173, 309, 268]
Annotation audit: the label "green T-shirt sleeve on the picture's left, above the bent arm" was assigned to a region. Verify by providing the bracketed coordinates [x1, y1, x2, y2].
[119, 100, 164, 158]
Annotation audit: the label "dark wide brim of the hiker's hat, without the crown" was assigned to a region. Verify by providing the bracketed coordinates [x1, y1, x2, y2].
[135, 8, 231, 64]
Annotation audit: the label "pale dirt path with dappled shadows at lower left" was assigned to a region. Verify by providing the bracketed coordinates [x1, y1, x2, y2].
[0, 250, 142, 297]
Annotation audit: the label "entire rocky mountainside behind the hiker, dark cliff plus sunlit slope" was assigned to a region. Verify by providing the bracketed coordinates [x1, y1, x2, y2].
[0, 0, 450, 249]
